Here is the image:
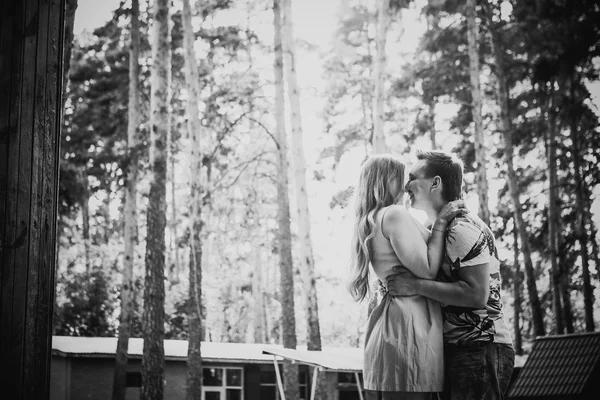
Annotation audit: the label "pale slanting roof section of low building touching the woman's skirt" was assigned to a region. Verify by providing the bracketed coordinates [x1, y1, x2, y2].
[263, 347, 363, 372]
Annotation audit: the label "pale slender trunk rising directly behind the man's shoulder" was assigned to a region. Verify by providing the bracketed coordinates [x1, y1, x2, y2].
[466, 0, 490, 225]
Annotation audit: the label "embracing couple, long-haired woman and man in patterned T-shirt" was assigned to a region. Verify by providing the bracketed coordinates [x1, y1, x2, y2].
[349, 151, 515, 400]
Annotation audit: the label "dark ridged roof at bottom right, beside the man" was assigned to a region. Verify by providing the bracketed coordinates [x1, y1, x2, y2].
[508, 332, 600, 398]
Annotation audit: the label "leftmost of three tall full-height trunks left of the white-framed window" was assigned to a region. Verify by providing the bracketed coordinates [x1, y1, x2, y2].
[113, 0, 140, 400]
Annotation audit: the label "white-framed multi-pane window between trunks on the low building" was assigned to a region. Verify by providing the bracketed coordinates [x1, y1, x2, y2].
[202, 367, 244, 400]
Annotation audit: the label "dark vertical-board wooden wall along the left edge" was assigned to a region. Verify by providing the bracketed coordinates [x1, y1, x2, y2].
[0, 0, 65, 400]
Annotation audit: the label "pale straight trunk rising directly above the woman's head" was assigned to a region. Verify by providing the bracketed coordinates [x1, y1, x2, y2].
[373, 0, 390, 154]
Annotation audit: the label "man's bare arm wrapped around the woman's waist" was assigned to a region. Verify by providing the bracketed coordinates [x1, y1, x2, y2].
[387, 263, 490, 308]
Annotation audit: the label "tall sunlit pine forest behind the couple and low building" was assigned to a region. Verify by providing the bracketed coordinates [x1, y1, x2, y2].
[53, 0, 600, 399]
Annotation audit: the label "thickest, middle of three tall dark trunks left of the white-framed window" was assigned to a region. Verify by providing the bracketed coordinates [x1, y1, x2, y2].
[140, 0, 171, 400]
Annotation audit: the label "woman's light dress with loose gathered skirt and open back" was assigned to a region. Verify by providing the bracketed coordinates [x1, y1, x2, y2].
[363, 207, 444, 399]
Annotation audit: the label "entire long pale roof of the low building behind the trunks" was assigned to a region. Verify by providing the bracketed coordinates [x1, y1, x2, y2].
[52, 336, 363, 372]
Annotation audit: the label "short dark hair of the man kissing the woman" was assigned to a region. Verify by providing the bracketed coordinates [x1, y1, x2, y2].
[416, 150, 464, 201]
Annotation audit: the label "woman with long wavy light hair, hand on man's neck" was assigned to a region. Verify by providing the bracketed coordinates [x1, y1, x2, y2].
[349, 155, 463, 400]
